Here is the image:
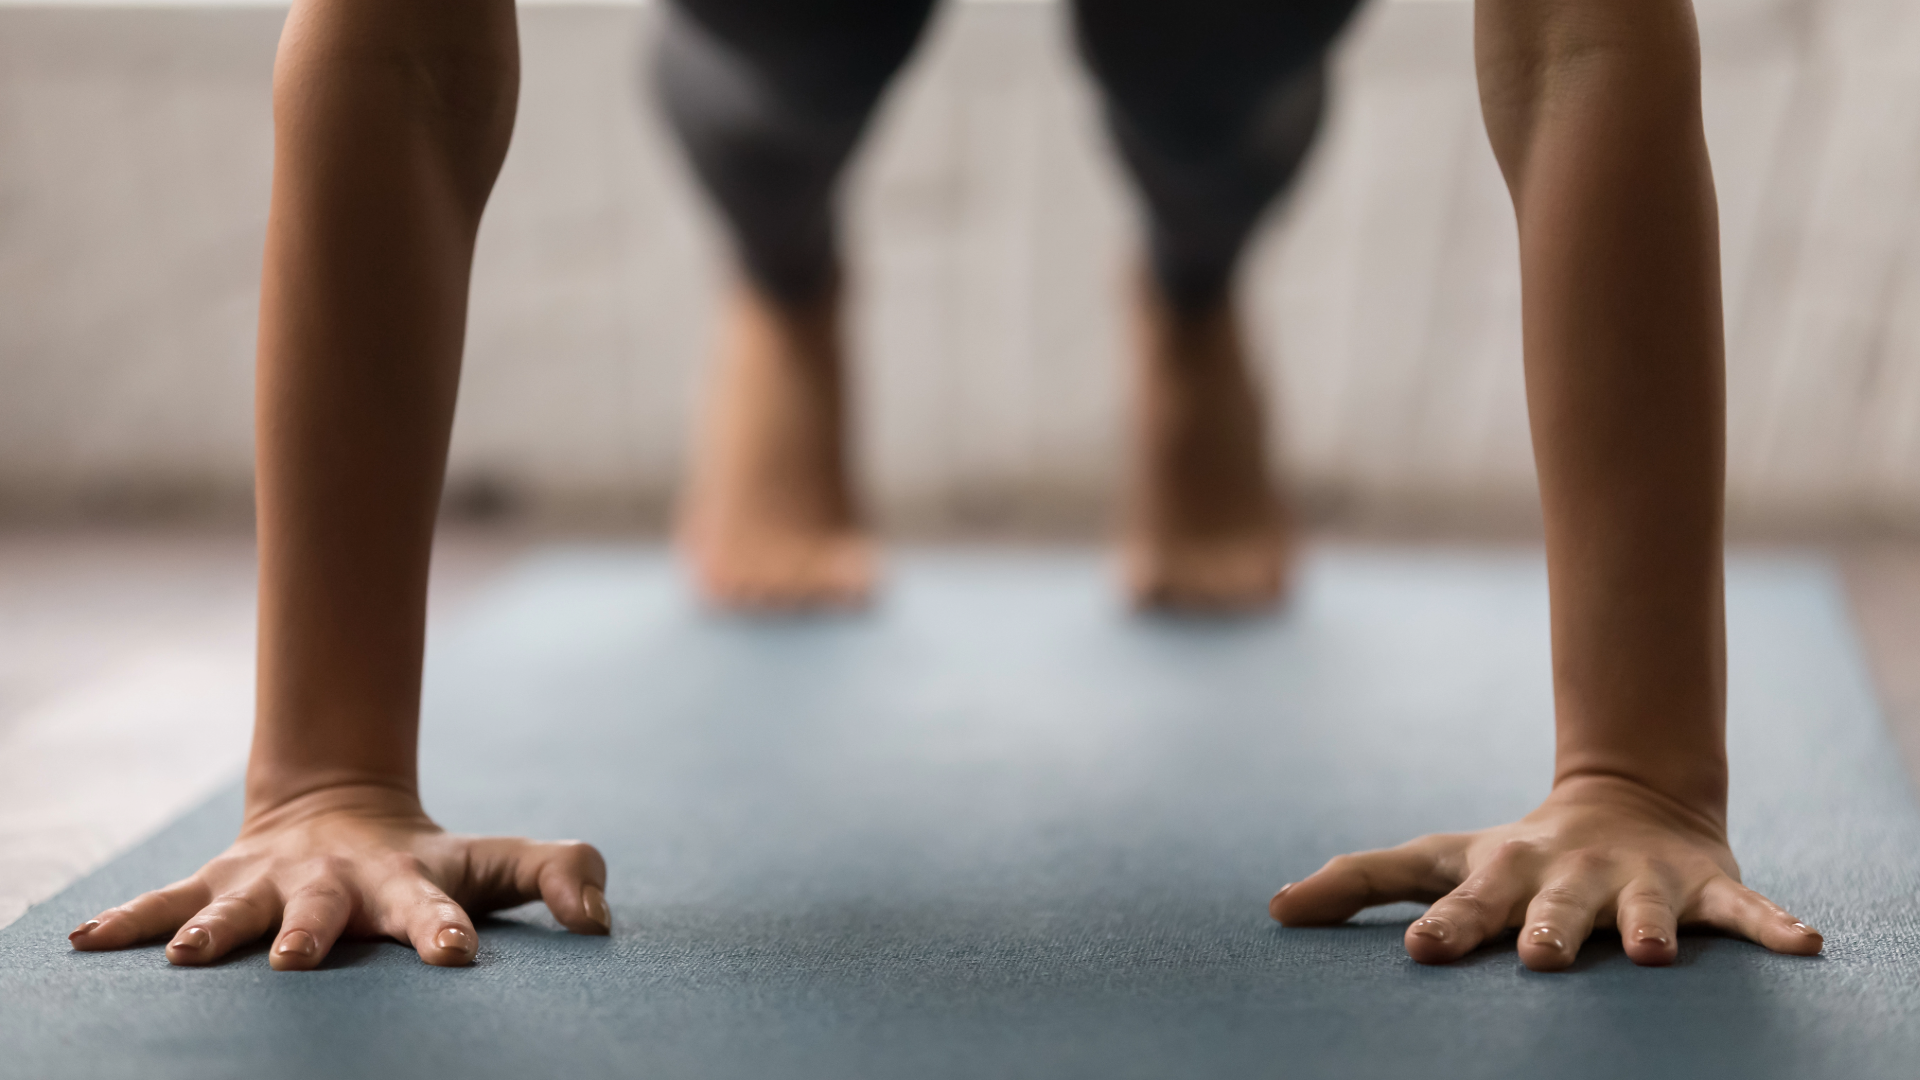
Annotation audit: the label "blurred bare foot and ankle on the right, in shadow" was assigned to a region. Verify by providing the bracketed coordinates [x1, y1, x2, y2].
[1123, 276, 1290, 611]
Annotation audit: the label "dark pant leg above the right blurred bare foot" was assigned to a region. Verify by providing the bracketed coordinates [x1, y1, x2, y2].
[1075, 0, 1359, 309]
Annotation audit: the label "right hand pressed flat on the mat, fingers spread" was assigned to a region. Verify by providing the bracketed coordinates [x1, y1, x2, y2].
[1269, 776, 1824, 970]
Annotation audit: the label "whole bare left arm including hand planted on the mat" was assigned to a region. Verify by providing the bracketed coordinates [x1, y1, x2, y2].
[73, 0, 609, 969]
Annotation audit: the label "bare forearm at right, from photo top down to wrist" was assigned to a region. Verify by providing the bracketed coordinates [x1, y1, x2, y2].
[1476, 0, 1726, 824]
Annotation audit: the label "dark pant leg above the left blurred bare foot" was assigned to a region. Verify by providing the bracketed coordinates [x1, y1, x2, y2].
[655, 0, 933, 304]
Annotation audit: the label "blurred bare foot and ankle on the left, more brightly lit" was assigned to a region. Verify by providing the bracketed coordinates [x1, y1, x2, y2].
[680, 284, 874, 611]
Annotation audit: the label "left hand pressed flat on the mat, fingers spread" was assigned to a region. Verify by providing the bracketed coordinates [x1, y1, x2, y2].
[69, 786, 612, 970]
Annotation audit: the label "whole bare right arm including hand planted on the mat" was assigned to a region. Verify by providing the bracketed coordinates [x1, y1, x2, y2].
[1273, 0, 1822, 970]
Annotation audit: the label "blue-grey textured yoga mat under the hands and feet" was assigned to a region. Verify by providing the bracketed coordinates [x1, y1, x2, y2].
[0, 550, 1920, 1080]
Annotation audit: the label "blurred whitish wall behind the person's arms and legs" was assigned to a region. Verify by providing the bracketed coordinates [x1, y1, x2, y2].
[0, 0, 1920, 534]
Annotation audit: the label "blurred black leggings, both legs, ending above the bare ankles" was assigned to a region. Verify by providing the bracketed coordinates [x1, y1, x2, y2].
[657, 0, 1359, 307]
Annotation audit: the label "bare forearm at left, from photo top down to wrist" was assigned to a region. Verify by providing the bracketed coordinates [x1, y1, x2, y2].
[248, 0, 516, 813]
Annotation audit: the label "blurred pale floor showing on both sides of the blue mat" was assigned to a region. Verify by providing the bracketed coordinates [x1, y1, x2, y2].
[0, 528, 1920, 926]
